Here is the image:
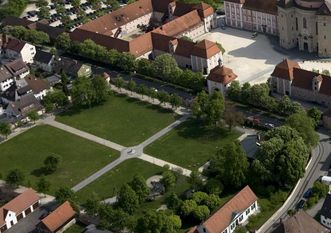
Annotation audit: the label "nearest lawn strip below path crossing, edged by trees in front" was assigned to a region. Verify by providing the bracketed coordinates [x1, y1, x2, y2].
[77, 159, 164, 203]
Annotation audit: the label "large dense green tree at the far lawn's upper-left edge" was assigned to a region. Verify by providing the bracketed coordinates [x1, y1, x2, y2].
[71, 77, 96, 107]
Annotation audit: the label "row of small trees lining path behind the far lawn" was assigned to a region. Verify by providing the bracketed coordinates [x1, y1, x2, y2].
[114, 76, 182, 108]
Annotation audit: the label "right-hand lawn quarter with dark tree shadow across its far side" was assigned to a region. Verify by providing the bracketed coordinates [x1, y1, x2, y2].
[145, 120, 240, 170]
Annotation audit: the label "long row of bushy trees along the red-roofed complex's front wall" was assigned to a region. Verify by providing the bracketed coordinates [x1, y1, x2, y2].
[56, 33, 205, 91]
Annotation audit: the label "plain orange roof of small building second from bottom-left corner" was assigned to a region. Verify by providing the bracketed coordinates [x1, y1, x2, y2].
[41, 201, 76, 232]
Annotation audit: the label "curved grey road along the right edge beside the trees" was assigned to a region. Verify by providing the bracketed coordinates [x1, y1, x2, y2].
[258, 128, 331, 233]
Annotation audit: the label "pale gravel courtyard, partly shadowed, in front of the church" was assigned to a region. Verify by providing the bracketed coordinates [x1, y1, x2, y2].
[195, 27, 320, 84]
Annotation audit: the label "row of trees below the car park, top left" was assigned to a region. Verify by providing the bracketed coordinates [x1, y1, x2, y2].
[3, 26, 50, 45]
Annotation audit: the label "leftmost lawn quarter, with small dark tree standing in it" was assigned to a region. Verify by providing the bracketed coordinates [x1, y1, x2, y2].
[0, 126, 119, 194]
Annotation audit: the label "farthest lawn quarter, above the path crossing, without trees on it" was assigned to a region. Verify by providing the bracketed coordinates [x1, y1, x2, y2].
[56, 94, 176, 146]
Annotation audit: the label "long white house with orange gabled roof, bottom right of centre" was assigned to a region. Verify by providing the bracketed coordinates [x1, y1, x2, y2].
[188, 186, 258, 233]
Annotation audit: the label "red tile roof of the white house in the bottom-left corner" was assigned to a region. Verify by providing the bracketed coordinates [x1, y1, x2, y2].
[0, 189, 40, 226]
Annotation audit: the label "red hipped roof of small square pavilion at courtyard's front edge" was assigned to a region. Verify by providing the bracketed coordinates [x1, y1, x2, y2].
[207, 66, 238, 85]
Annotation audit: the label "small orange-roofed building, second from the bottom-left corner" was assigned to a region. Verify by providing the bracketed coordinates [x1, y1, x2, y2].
[37, 201, 76, 233]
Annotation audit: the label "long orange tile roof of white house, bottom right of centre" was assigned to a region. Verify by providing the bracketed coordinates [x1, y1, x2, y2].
[203, 186, 257, 233]
